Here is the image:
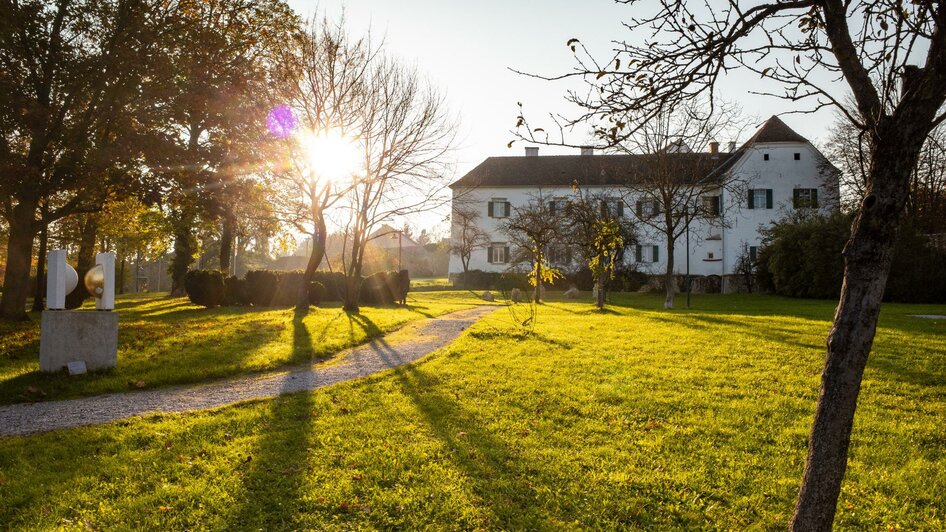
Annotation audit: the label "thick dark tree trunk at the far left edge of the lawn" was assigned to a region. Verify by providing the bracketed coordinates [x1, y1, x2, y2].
[0, 199, 37, 320]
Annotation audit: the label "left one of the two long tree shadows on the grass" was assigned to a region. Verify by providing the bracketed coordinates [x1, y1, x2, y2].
[227, 312, 314, 530]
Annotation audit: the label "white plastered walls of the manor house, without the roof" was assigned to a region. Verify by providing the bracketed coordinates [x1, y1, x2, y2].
[449, 142, 838, 284]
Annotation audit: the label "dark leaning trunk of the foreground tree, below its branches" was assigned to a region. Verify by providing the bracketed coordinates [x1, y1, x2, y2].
[791, 122, 925, 531]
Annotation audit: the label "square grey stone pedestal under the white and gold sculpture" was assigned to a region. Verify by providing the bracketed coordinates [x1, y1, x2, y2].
[39, 310, 118, 373]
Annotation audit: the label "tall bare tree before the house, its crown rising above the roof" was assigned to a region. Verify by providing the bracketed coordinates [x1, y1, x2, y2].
[618, 102, 746, 309]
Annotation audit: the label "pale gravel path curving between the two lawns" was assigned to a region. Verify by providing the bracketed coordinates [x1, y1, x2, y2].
[0, 306, 496, 436]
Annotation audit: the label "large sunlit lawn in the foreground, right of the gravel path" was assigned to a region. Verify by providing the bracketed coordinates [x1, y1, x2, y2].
[0, 295, 946, 530]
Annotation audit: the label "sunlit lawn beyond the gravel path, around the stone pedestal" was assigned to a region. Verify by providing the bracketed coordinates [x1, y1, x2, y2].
[0, 292, 475, 404]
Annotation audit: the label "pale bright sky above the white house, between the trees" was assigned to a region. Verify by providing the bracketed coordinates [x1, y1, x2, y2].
[289, 0, 833, 237]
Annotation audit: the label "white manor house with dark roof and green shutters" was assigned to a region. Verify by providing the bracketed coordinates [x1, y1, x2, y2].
[449, 116, 839, 292]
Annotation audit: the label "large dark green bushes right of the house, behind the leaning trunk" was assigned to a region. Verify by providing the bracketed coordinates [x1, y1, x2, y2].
[756, 214, 946, 303]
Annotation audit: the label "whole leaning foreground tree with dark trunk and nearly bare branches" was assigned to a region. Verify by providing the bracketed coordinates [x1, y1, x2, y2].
[520, 0, 946, 530]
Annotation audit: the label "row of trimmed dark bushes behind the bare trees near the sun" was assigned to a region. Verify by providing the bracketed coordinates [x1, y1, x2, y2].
[184, 270, 410, 308]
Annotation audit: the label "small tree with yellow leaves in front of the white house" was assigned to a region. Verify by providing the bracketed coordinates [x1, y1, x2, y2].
[564, 183, 636, 309]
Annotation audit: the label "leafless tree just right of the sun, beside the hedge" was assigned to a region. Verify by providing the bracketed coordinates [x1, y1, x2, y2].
[342, 56, 455, 311]
